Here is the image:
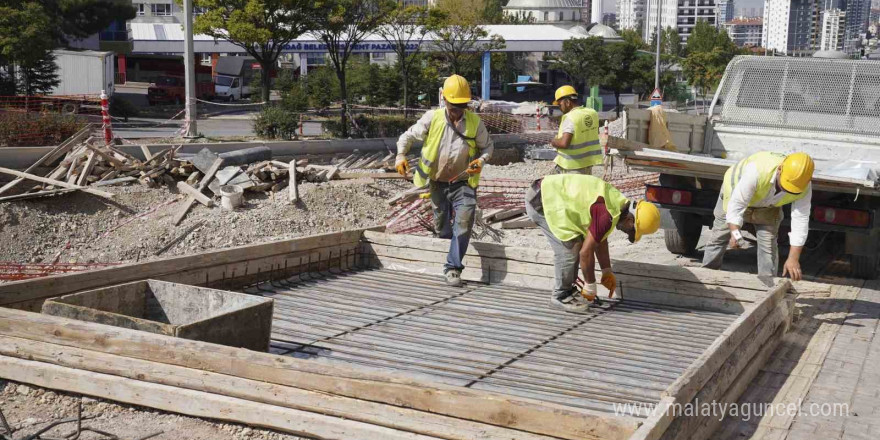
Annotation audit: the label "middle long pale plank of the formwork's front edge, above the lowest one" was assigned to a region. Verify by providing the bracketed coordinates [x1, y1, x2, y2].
[0, 336, 545, 440]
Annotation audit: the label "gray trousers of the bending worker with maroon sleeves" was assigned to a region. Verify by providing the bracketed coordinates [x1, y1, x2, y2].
[526, 185, 584, 299]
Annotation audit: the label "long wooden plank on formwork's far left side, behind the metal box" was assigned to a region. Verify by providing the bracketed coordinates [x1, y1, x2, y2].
[0, 229, 364, 305]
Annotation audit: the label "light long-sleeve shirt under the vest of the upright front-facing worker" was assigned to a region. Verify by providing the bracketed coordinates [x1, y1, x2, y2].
[397, 110, 495, 182]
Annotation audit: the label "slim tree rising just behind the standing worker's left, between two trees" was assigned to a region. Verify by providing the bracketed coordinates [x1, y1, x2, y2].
[377, 6, 444, 117]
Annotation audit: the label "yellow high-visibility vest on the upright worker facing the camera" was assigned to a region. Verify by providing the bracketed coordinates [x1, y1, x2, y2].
[413, 109, 480, 188]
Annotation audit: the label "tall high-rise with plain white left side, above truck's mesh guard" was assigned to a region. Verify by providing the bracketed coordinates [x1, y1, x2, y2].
[763, 0, 815, 56]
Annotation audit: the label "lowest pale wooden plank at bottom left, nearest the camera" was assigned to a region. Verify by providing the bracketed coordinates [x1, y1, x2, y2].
[0, 356, 436, 440]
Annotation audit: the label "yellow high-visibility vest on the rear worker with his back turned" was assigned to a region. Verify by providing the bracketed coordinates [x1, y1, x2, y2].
[553, 107, 602, 170]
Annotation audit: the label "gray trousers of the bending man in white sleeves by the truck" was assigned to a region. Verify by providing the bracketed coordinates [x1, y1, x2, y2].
[703, 195, 783, 276]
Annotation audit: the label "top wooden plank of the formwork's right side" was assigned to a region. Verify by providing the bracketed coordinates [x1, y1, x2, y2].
[663, 280, 791, 402]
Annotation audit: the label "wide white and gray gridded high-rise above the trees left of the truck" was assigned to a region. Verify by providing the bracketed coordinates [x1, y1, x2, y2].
[643, 0, 716, 43]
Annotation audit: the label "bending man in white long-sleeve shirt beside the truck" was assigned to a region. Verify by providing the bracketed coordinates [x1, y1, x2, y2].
[703, 152, 815, 281]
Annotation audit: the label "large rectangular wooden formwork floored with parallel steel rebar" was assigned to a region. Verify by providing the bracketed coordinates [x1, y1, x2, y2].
[0, 230, 801, 439]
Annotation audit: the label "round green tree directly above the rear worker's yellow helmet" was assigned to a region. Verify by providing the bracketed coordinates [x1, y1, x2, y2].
[551, 37, 607, 96]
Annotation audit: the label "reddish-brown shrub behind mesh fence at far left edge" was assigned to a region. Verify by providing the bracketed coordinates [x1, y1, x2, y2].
[0, 112, 86, 147]
